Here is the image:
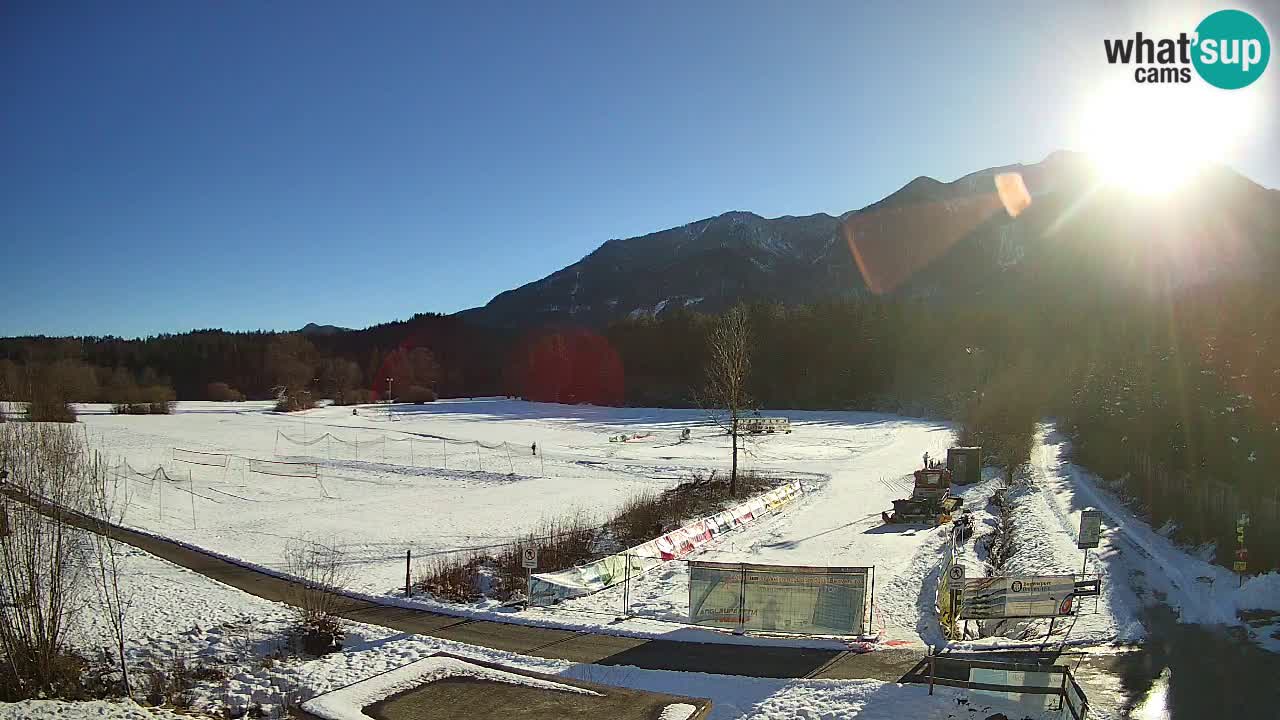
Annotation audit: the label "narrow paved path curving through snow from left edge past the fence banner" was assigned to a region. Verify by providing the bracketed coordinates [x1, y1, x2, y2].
[0, 486, 924, 680]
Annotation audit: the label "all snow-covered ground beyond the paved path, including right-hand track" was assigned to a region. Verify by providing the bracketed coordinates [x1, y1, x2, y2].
[81, 398, 1271, 646]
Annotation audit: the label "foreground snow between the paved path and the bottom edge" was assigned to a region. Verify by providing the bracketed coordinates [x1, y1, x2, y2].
[40, 535, 1050, 720]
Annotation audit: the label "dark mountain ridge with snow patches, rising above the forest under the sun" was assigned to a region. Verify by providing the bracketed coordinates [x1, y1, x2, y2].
[462, 152, 1280, 327]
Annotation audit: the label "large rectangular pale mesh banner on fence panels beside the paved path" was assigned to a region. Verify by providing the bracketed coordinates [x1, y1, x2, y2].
[689, 560, 872, 635]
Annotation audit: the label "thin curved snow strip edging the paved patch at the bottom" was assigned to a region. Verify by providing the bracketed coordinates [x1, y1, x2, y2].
[302, 657, 596, 720]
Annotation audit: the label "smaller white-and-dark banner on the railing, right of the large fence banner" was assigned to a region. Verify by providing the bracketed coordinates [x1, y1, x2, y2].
[959, 575, 1075, 620]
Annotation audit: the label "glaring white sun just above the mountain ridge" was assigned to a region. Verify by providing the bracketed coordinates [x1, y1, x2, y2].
[1079, 83, 1254, 196]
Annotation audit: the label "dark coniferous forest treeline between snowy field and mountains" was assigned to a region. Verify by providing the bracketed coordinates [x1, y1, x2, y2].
[0, 281, 1280, 568]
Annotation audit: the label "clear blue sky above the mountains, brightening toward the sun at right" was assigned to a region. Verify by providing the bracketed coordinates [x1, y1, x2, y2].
[0, 0, 1280, 336]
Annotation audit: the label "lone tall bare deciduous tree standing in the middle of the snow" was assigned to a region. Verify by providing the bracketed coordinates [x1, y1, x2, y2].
[701, 305, 751, 496]
